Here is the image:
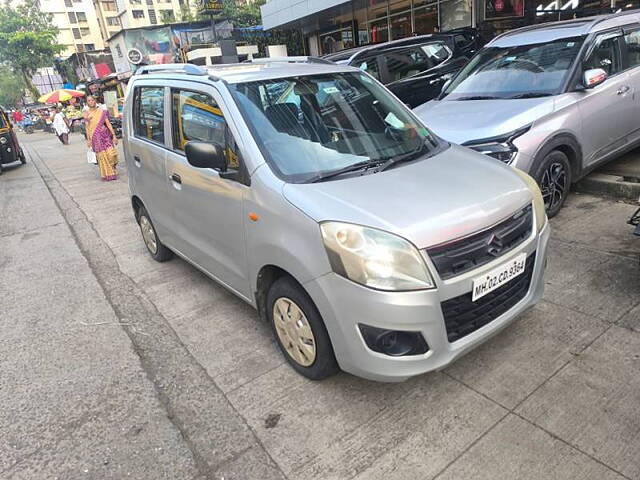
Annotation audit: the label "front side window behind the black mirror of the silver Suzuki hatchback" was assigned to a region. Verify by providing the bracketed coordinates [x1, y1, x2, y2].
[171, 89, 240, 169]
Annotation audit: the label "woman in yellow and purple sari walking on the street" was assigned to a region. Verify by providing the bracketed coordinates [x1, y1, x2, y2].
[84, 96, 118, 182]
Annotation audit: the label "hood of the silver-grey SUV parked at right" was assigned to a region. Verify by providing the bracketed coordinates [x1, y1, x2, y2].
[413, 97, 555, 144]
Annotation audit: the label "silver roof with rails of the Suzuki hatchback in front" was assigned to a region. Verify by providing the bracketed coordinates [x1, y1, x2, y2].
[134, 59, 360, 84]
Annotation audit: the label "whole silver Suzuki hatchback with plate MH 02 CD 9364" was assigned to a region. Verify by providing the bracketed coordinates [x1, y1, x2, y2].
[124, 60, 549, 380]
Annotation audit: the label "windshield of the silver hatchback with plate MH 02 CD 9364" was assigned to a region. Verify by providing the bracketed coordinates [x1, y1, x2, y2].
[229, 72, 438, 183]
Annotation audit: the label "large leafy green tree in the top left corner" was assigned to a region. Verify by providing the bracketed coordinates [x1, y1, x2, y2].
[0, 0, 64, 98]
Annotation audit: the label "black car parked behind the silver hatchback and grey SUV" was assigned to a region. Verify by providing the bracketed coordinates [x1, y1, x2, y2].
[323, 28, 482, 108]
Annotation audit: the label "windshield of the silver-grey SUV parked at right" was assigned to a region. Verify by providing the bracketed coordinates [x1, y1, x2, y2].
[443, 37, 584, 100]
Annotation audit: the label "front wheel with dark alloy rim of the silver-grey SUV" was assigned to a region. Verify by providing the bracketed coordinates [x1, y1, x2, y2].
[533, 150, 571, 218]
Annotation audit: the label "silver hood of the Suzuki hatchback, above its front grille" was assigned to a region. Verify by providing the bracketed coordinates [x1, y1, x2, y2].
[283, 145, 532, 248]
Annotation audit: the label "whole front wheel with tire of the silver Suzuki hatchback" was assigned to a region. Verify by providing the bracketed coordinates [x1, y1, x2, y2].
[267, 276, 340, 380]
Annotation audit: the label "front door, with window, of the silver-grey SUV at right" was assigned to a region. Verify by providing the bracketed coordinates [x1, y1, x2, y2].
[578, 32, 637, 167]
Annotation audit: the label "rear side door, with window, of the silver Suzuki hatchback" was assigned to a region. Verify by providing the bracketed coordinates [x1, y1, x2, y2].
[127, 83, 171, 237]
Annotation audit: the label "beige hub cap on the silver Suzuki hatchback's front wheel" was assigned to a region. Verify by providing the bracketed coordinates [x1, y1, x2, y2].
[273, 297, 316, 367]
